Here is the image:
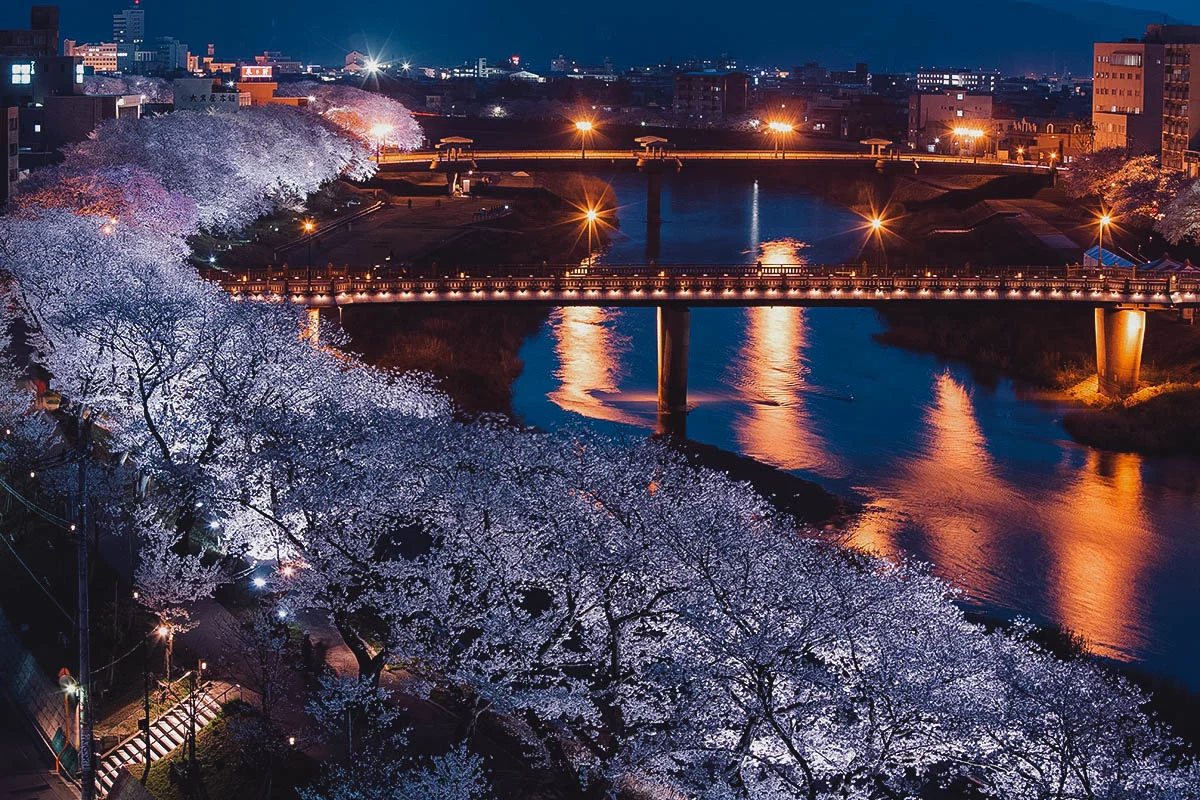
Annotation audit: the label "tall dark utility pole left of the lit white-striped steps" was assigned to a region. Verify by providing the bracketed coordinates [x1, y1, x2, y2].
[74, 417, 96, 800]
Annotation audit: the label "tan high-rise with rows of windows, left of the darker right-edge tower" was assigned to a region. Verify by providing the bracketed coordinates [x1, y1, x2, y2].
[1092, 41, 1163, 155]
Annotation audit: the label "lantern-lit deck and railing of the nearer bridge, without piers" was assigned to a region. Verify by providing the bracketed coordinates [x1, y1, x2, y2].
[216, 265, 1200, 308]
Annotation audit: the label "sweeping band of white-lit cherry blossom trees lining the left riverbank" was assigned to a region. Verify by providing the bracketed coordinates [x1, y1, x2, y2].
[0, 90, 1196, 800]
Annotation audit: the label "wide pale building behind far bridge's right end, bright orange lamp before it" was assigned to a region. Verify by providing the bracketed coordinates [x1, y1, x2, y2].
[908, 90, 996, 155]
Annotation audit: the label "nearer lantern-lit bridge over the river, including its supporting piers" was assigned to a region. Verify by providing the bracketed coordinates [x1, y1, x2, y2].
[216, 264, 1200, 428]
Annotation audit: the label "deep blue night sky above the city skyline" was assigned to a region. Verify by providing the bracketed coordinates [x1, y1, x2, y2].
[0, 0, 1200, 73]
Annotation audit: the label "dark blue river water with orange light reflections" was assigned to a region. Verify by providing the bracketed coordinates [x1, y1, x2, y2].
[514, 173, 1200, 691]
